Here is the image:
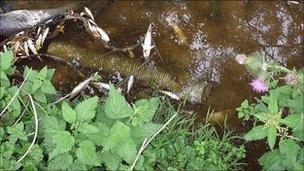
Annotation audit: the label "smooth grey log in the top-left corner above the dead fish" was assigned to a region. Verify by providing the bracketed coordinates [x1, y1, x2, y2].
[0, 2, 78, 36]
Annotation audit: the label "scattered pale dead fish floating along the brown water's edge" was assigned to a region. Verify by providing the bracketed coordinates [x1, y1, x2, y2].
[3, 7, 180, 100]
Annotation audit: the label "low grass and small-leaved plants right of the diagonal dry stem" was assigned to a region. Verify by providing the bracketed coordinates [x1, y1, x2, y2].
[138, 103, 245, 170]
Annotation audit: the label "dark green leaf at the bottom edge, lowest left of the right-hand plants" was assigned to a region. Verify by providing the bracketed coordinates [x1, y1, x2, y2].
[259, 149, 286, 170]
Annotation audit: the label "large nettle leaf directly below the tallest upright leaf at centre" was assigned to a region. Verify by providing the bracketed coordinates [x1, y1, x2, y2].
[104, 121, 130, 151]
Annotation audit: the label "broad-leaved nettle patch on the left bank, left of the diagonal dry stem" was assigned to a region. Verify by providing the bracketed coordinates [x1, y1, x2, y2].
[0, 51, 160, 170]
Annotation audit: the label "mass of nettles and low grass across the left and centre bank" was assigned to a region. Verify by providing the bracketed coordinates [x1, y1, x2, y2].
[0, 51, 244, 170]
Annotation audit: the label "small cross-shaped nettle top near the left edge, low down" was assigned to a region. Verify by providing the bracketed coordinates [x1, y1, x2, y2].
[7, 122, 27, 142]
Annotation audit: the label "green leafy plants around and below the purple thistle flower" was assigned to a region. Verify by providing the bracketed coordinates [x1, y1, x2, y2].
[237, 54, 304, 170]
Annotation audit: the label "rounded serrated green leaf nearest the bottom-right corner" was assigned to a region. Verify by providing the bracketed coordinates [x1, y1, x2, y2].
[279, 139, 301, 161]
